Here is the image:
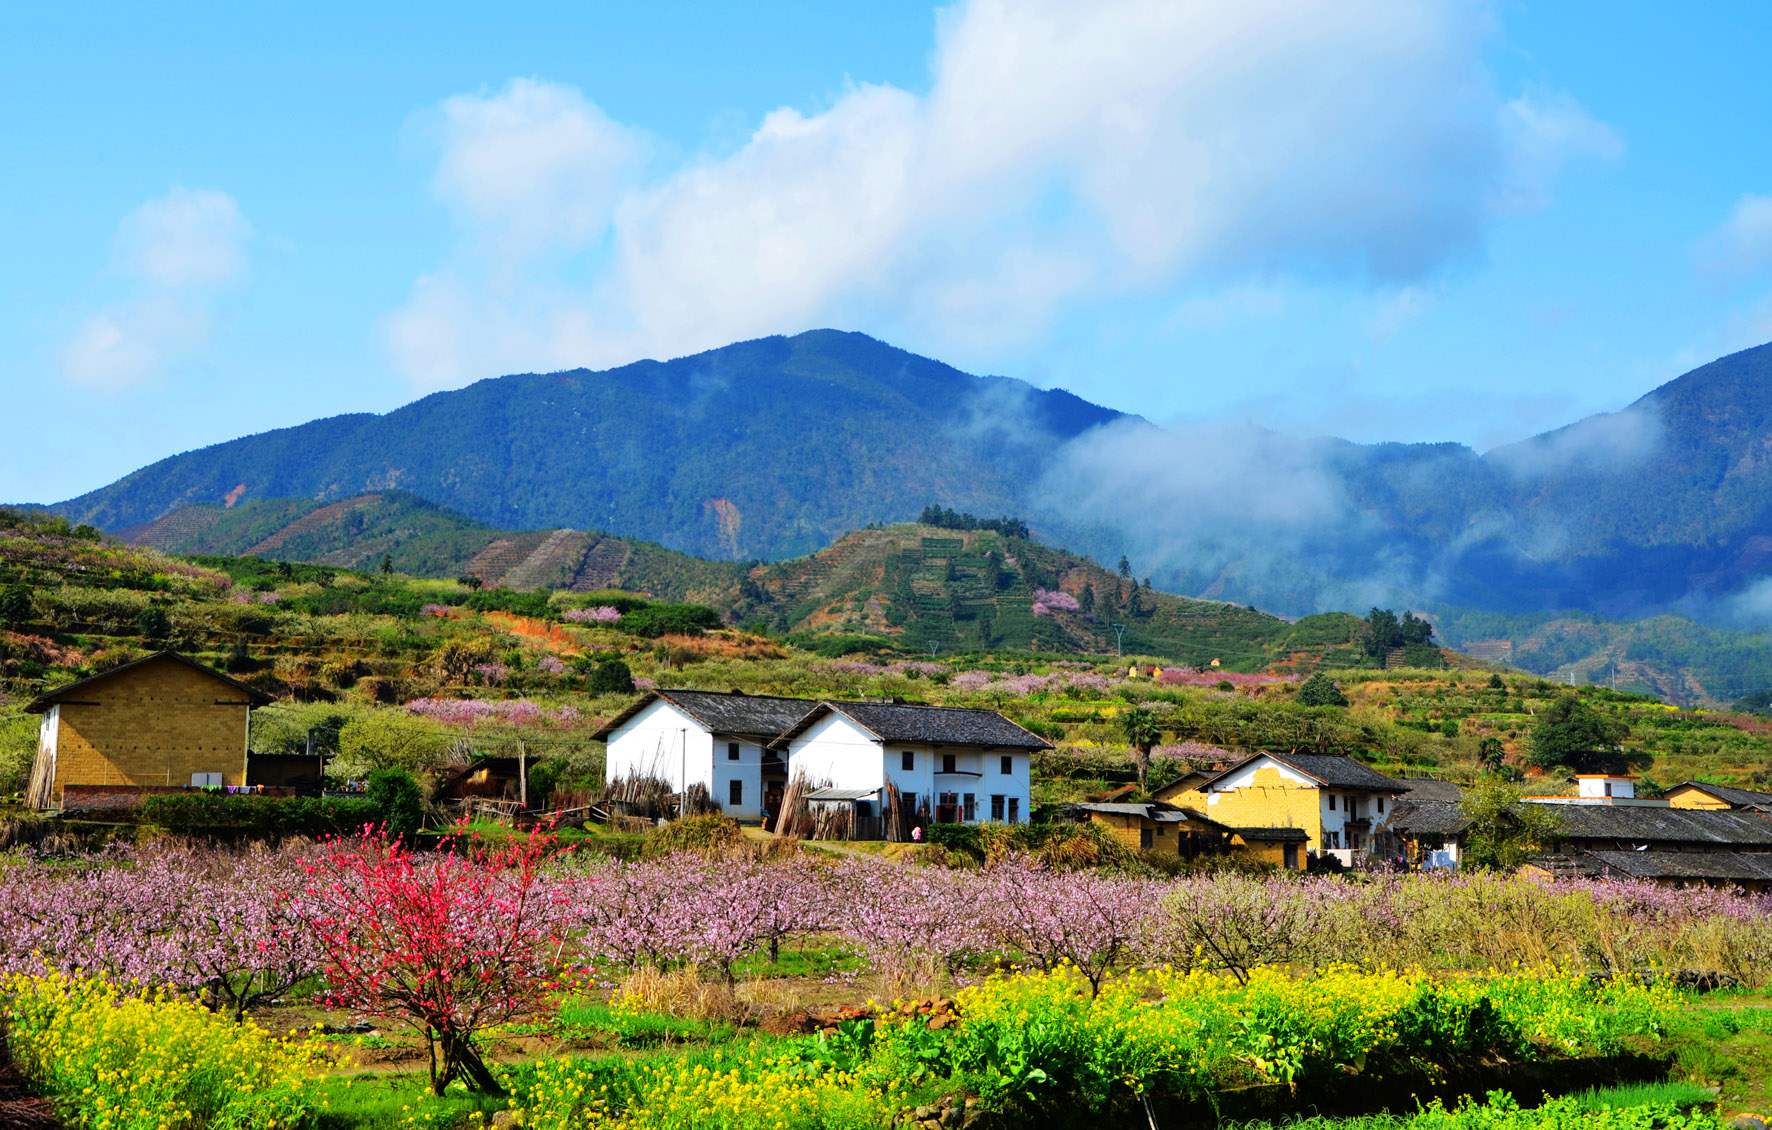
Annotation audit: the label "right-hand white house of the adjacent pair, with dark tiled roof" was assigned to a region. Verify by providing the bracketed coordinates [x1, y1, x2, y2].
[771, 701, 1053, 824]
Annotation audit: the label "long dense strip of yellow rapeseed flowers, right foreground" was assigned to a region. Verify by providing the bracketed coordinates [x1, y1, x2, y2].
[952, 965, 1675, 1102]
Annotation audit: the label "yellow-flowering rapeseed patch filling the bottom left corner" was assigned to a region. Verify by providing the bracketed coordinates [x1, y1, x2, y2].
[0, 974, 326, 1130]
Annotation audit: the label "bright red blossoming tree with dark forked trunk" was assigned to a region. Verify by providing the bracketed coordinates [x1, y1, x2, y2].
[308, 832, 569, 1095]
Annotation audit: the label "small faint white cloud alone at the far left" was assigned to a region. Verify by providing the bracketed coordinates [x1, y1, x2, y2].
[62, 188, 252, 390]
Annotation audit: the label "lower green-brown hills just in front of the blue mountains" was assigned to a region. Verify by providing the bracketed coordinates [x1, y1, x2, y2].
[128, 491, 1367, 671]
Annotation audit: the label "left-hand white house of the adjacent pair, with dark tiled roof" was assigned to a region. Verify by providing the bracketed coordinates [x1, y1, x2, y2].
[594, 691, 819, 820]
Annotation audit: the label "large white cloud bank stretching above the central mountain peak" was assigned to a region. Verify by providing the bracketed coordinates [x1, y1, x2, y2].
[385, 0, 1616, 386]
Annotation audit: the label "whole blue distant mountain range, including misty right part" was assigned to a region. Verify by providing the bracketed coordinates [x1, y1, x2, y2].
[44, 329, 1772, 630]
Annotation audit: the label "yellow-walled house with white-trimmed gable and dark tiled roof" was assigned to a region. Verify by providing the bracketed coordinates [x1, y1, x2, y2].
[1164, 753, 1409, 868]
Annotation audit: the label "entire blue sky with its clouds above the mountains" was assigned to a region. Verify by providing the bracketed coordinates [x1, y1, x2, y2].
[0, 0, 1772, 501]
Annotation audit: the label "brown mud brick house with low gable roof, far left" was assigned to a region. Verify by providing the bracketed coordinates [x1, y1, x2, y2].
[25, 652, 271, 808]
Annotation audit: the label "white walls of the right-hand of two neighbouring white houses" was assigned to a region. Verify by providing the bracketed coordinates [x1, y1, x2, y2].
[787, 714, 1034, 821]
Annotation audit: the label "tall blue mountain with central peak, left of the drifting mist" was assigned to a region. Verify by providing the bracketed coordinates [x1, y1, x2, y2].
[58, 329, 1118, 560]
